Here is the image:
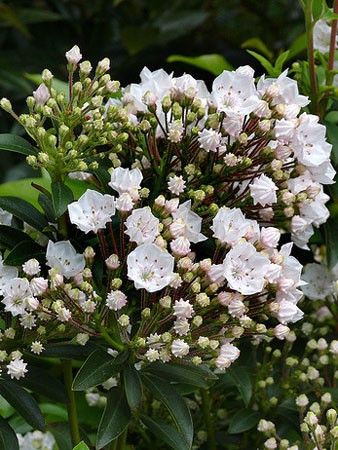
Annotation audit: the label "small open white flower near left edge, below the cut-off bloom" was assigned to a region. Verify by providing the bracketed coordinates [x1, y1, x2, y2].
[2, 278, 32, 316]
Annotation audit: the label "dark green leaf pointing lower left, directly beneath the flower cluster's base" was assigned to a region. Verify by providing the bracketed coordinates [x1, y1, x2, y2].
[73, 350, 128, 391]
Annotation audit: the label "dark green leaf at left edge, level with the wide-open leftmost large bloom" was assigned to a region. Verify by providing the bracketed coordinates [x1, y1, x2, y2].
[0, 196, 48, 231]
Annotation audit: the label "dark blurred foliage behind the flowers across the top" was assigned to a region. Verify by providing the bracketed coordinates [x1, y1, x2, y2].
[0, 0, 304, 182]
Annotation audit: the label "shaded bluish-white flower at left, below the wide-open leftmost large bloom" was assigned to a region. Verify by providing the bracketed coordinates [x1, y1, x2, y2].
[46, 241, 85, 278]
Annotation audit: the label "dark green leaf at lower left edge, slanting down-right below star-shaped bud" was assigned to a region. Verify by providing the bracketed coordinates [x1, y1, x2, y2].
[0, 380, 45, 430]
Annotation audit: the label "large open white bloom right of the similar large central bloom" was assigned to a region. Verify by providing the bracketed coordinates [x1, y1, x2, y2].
[219, 242, 270, 295]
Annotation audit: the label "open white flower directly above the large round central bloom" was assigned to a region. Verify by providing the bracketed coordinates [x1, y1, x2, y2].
[125, 206, 160, 245]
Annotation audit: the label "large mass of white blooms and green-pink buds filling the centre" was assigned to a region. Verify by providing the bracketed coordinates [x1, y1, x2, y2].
[0, 47, 334, 378]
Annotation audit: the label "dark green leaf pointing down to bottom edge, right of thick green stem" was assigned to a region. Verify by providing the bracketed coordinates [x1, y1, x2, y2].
[96, 388, 131, 450]
